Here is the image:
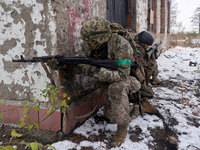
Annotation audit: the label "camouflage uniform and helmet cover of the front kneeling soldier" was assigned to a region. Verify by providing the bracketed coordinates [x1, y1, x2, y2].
[81, 18, 141, 126]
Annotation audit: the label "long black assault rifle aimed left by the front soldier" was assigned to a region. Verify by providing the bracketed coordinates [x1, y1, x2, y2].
[12, 55, 126, 70]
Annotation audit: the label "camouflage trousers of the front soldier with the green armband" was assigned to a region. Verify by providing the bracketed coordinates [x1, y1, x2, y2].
[104, 76, 141, 126]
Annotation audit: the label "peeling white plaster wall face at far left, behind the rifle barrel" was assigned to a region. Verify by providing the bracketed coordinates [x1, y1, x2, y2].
[0, 0, 56, 100]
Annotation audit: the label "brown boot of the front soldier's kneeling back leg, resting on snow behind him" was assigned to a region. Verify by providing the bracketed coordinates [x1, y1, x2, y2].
[140, 97, 158, 115]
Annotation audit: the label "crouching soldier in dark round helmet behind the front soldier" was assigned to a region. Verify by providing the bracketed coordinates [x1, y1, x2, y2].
[134, 31, 159, 98]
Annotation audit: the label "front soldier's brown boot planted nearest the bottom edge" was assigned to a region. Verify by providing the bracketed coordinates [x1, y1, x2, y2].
[110, 125, 128, 147]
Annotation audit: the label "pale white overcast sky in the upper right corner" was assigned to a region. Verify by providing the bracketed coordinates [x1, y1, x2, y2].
[175, 0, 200, 31]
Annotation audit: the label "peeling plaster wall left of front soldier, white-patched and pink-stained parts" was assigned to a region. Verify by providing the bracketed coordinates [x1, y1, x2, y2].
[0, 0, 106, 101]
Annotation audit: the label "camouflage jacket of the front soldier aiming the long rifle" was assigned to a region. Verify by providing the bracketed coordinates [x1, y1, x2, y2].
[81, 34, 134, 83]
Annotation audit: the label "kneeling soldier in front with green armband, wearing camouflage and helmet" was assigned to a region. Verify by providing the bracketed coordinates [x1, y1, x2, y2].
[47, 17, 141, 147]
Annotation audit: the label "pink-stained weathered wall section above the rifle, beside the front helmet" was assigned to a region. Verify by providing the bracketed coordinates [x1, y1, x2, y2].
[52, 0, 106, 56]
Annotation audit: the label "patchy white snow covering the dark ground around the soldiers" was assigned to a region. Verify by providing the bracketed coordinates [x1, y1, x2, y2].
[52, 47, 200, 150]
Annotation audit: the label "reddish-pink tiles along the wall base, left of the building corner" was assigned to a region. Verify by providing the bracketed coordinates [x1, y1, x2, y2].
[0, 102, 61, 132]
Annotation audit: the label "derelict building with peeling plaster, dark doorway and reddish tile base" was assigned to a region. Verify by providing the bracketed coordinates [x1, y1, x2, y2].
[0, 0, 170, 133]
